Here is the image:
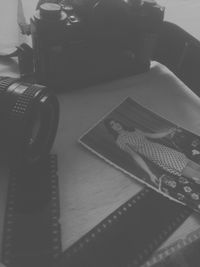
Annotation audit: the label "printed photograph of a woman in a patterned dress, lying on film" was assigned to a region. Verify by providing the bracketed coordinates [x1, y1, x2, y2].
[79, 98, 200, 212]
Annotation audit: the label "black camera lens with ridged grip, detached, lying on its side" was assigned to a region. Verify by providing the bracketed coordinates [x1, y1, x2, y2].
[0, 77, 59, 165]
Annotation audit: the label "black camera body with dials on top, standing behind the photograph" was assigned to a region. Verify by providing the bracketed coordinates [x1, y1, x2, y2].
[31, 0, 164, 90]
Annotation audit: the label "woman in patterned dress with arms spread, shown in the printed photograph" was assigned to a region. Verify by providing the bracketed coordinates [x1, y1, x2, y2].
[104, 119, 200, 184]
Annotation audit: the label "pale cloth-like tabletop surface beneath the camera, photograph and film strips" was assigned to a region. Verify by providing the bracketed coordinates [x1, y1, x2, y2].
[54, 62, 200, 252]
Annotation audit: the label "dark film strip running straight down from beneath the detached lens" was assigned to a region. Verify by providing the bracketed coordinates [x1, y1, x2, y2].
[2, 155, 61, 267]
